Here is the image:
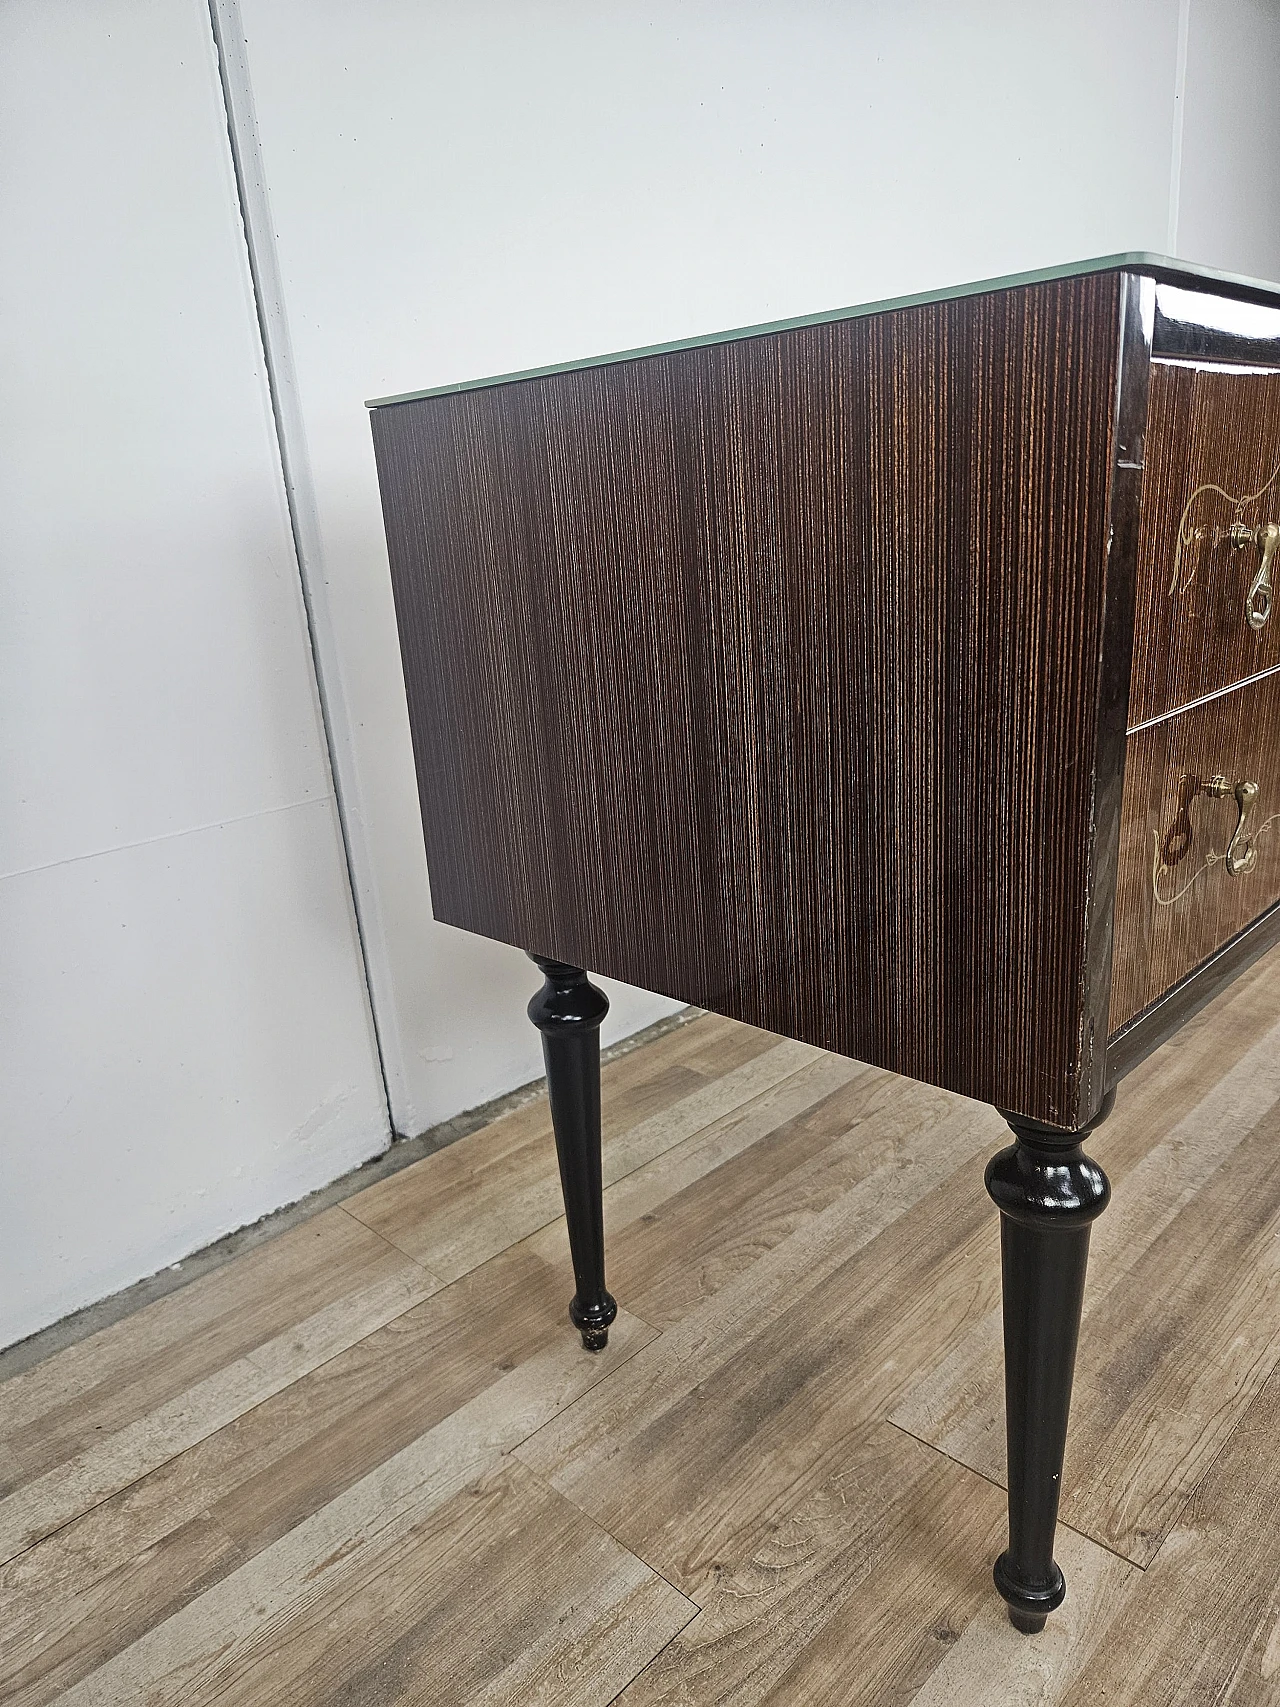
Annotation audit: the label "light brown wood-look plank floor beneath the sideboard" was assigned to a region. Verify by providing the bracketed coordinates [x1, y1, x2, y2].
[0, 956, 1280, 1707]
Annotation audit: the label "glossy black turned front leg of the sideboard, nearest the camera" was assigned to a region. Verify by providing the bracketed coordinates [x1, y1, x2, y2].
[986, 1096, 1114, 1635]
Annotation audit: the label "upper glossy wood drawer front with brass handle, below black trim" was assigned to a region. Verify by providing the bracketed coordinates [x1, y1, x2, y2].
[1128, 352, 1280, 727]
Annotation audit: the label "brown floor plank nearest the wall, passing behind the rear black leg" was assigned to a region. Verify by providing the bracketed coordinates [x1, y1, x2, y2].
[345, 1016, 821, 1280]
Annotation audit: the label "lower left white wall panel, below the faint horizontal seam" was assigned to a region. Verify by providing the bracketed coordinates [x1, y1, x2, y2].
[0, 799, 386, 1345]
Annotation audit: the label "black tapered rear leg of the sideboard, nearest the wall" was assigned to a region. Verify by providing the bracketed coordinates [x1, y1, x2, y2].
[529, 954, 618, 1352]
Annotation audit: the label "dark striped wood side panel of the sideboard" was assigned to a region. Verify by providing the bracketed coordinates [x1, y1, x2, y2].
[374, 273, 1128, 1125]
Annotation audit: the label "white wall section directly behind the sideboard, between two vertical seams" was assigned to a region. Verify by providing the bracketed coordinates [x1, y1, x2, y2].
[218, 0, 1178, 1130]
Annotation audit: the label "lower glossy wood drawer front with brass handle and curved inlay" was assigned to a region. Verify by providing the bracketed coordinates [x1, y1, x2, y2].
[1111, 674, 1280, 1034]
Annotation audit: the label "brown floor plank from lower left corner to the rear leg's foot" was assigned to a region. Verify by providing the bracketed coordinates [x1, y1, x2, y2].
[0, 1251, 610, 1704]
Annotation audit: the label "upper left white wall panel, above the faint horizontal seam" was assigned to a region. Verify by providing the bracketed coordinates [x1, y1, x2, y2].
[0, 0, 341, 872]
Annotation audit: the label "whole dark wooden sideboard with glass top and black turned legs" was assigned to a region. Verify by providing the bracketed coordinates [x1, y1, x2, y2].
[372, 254, 1280, 1630]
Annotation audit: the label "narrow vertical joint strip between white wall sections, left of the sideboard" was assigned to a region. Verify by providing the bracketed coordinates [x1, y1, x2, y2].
[208, 0, 396, 1139]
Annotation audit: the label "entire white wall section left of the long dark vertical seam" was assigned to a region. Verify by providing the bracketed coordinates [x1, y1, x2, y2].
[0, 0, 387, 1343]
